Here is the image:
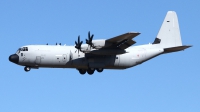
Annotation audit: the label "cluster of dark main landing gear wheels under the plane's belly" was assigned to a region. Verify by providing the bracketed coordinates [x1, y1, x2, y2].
[78, 68, 103, 75]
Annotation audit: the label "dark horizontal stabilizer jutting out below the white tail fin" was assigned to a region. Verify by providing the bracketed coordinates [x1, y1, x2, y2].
[164, 45, 192, 53]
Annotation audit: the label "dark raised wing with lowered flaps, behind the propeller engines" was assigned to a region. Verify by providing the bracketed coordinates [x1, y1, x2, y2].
[104, 32, 140, 49]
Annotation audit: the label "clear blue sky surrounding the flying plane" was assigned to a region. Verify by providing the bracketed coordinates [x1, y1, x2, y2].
[0, 0, 200, 112]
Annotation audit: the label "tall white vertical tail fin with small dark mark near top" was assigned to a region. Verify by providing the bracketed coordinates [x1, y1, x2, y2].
[153, 11, 182, 48]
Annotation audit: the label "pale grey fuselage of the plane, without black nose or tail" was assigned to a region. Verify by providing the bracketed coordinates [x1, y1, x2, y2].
[16, 44, 163, 69]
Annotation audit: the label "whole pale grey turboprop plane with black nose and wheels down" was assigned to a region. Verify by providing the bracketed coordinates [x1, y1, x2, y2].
[9, 11, 191, 75]
